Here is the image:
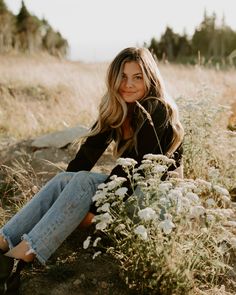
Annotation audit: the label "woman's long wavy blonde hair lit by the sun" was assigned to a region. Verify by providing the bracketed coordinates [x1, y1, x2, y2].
[83, 47, 184, 157]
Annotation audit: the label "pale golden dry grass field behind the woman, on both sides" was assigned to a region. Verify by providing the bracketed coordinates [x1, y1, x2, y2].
[0, 55, 236, 138]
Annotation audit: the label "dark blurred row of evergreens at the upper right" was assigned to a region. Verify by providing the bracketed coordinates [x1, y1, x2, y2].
[144, 11, 236, 66]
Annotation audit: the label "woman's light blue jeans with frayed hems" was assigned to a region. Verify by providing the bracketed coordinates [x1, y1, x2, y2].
[0, 171, 107, 264]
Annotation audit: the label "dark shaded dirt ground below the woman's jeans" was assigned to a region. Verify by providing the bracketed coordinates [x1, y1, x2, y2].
[21, 229, 135, 295]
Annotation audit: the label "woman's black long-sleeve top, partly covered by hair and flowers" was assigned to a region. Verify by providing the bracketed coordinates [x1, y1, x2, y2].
[66, 99, 182, 213]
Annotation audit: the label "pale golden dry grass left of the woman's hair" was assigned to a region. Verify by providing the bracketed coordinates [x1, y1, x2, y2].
[0, 56, 105, 138]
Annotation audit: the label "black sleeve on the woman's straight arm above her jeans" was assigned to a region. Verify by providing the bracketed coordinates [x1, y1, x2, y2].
[66, 130, 112, 172]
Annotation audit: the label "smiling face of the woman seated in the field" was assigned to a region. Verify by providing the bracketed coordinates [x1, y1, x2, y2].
[118, 61, 146, 103]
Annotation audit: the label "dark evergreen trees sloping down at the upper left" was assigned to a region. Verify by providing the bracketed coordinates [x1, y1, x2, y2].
[0, 0, 69, 56]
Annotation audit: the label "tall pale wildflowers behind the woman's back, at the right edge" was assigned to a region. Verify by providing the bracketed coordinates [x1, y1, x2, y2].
[178, 94, 236, 190]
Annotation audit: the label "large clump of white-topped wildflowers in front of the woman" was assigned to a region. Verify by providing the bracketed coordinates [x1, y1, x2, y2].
[85, 154, 236, 294]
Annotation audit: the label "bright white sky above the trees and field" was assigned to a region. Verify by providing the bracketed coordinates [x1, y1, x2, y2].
[5, 0, 236, 62]
